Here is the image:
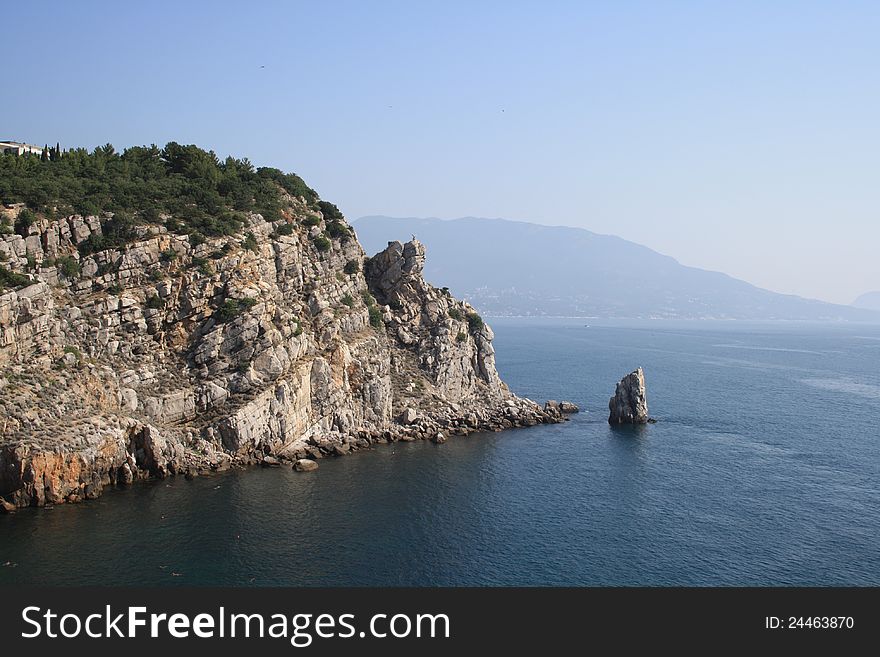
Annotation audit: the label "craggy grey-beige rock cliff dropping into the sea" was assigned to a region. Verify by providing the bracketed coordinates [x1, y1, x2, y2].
[0, 195, 561, 506]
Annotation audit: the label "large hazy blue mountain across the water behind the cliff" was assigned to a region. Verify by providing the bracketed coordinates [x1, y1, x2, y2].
[354, 216, 880, 320]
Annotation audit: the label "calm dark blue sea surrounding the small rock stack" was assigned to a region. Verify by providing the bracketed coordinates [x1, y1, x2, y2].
[0, 320, 880, 586]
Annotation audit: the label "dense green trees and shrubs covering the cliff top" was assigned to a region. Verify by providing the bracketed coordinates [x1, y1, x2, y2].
[0, 142, 322, 241]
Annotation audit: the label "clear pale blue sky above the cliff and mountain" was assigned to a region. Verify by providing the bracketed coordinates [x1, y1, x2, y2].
[0, 0, 880, 303]
